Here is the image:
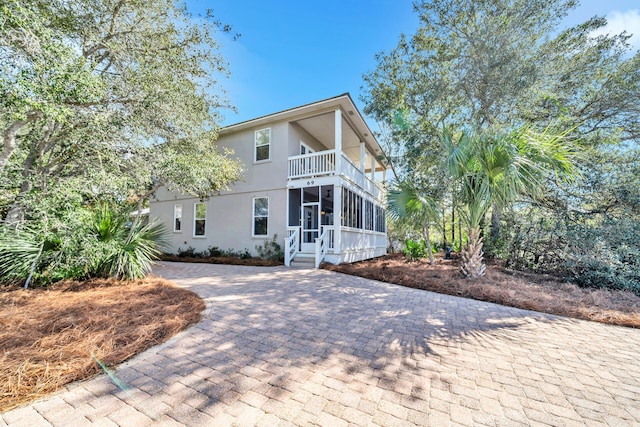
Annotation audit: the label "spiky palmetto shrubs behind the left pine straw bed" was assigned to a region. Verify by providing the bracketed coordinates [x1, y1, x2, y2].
[0, 206, 166, 285]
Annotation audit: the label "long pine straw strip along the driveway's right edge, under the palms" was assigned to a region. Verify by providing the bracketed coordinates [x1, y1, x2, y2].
[322, 254, 640, 328]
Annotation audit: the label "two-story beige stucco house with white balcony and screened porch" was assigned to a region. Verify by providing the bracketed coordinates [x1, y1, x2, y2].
[150, 93, 387, 267]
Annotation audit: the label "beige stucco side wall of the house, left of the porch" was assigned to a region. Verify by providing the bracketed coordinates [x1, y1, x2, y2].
[150, 118, 292, 255]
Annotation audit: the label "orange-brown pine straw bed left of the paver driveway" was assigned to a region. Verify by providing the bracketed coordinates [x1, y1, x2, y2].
[0, 277, 205, 412]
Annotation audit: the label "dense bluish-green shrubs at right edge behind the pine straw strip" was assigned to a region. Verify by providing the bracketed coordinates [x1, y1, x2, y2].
[497, 146, 640, 293]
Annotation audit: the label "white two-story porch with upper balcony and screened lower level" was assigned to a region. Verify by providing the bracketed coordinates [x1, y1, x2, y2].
[285, 108, 387, 267]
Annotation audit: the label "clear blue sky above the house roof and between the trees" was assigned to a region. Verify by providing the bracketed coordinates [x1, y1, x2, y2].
[186, 0, 640, 127]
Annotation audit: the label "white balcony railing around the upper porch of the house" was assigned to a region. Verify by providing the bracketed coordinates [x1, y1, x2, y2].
[287, 150, 383, 197]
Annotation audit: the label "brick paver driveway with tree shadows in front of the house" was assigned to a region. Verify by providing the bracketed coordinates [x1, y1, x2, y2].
[0, 263, 640, 427]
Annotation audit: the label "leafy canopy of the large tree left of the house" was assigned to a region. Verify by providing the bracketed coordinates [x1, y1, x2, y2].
[0, 0, 242, 223]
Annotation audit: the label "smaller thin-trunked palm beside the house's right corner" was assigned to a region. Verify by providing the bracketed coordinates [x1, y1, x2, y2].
[387, 181, 439, 265]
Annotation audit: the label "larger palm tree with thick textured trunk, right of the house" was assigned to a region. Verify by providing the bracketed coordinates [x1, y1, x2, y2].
[441, 128, 576, 278]
